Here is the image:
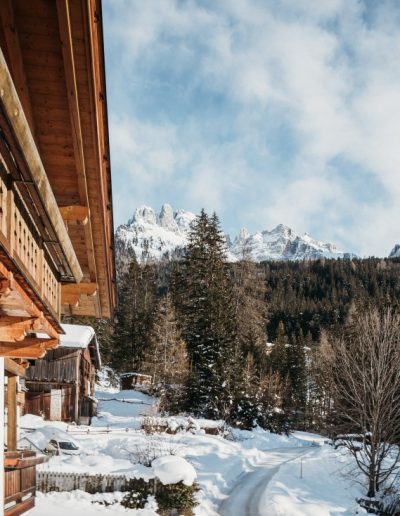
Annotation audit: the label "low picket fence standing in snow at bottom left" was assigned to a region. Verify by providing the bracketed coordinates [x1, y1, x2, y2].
[36, 471, 157, 494]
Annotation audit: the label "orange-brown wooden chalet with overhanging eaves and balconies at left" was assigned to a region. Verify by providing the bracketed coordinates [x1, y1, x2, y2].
[0, 0, 115, 516]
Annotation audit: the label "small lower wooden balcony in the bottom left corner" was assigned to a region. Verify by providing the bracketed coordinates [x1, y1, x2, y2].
[4, 451, 48, 516]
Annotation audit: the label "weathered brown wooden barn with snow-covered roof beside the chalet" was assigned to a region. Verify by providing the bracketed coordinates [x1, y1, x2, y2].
[24, 324, 101, 425]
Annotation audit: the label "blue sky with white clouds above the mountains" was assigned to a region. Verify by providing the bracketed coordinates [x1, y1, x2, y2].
[103, 0, 400, 256]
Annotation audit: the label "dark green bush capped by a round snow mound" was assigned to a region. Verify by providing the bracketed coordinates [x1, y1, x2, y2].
[155, 482, 199, 516]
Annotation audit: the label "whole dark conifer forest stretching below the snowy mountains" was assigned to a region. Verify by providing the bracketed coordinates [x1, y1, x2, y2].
[76, 211, 400, 444]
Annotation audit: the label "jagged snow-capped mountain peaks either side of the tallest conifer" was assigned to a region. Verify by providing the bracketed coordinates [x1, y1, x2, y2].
[116, 204, 352, 262]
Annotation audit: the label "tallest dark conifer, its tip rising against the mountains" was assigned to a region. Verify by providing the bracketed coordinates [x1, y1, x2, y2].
[176, 210, 236, 418]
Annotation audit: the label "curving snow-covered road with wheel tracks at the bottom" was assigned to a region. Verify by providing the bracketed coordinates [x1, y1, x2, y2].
[218, 447, 312, 516]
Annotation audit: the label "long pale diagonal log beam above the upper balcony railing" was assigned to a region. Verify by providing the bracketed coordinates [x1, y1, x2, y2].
[0, 45, 83, 282]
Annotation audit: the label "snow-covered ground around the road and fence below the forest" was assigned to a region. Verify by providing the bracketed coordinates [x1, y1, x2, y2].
[21, 391, 362, 516]
